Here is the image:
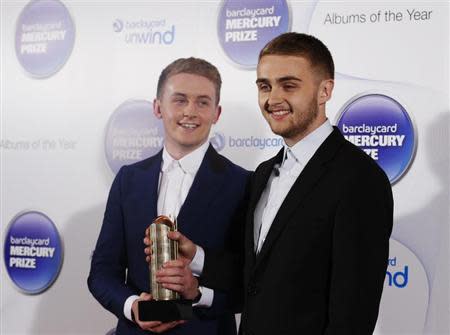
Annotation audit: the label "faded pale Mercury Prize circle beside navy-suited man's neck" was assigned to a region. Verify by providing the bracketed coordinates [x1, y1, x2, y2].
[105, 100, 164, 173]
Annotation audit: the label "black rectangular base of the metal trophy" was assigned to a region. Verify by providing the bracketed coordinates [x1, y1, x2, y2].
[138, 300, 192, 322]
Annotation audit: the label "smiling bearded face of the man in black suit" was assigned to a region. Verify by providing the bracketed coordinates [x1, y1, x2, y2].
[256, 55, 333, 146]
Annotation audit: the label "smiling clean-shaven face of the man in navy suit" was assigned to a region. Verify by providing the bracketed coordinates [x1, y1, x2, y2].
[153, 73, 221, 159]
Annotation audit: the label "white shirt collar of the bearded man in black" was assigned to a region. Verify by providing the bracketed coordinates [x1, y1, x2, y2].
[281, 119, 333, 166]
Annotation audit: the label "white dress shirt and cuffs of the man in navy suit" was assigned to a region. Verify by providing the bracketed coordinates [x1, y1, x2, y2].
[123, 141, 214, 320]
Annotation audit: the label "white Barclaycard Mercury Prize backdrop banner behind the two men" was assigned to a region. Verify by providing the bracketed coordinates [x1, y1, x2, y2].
[0, 0, 450, 335]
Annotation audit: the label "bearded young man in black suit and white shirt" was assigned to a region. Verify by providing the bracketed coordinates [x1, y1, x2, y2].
[149, 33, 393, 335]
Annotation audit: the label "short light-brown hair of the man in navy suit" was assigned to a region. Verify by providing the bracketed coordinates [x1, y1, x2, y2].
[156, 57, 222, 104]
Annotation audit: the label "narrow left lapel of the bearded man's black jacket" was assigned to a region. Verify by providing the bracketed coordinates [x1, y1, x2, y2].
[245, 147, 284, 264]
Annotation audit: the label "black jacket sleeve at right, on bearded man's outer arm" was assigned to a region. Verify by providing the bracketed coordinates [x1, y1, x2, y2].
[324, 170, 393, 335]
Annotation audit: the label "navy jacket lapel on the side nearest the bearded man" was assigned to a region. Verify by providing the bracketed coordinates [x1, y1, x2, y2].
[177, 145, 226, 242]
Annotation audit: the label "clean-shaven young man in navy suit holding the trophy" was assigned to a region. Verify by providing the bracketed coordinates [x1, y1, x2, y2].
[88, 58, 249, 335]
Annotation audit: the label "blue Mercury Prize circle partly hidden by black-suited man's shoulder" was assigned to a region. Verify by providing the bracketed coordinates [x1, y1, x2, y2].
[337, 94, 416, 184]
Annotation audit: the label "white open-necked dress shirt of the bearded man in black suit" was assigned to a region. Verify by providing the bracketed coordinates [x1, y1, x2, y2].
[253, 120, 333, 253]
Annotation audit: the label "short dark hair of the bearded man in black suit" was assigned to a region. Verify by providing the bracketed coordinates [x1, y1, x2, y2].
[258, 32, 334, 79]
